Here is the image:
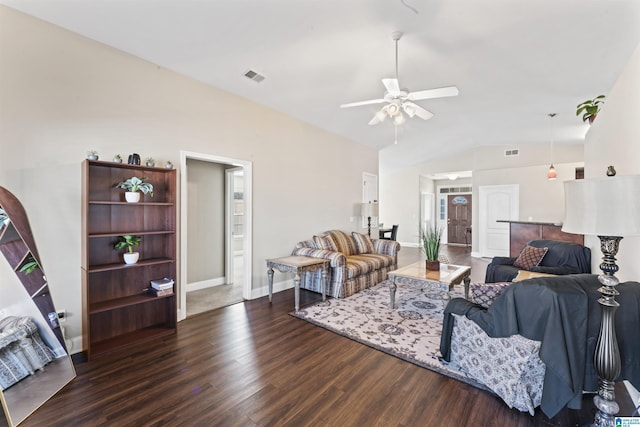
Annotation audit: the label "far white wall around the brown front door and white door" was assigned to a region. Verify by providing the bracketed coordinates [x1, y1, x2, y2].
[380, 143, 583, 253]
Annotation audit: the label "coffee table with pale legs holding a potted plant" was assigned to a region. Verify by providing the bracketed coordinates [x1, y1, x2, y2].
[388, 261, 471, 310]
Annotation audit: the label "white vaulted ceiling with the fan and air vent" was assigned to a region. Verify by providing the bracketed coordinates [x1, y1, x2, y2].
[5, 0, 640, 174]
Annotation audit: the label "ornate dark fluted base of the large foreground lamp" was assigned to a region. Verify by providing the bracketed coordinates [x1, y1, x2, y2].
[592, 236, 622, 427]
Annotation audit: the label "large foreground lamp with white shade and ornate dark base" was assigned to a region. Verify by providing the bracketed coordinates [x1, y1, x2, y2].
[562, 175, 640, 427]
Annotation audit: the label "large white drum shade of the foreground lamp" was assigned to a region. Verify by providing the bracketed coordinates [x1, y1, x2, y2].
[562, 175, 640, 237]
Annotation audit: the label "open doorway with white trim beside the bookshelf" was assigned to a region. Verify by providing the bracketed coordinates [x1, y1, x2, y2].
[178, 152, 252, 320]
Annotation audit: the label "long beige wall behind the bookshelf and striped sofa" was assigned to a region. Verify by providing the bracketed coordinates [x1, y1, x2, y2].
[0, 6, 378, 351]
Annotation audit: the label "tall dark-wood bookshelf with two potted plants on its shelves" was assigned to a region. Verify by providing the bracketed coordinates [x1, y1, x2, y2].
[82, 160, 177, 358]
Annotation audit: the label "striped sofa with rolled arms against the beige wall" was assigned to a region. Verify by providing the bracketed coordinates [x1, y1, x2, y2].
[292, 230, 400, 298]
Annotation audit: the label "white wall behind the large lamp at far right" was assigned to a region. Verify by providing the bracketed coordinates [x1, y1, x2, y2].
[584, 42, 640, 281]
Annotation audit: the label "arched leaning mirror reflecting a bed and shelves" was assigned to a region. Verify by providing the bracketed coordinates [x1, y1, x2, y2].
[0, 187, 76, 426]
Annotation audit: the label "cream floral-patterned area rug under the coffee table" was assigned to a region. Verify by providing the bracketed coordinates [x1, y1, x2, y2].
[291, 281, 486, 390]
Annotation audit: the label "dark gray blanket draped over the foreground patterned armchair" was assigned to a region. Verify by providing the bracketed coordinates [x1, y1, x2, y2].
[440, 274, 640, 418]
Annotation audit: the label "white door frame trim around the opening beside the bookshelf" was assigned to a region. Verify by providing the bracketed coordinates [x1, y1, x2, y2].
[178, 150, 253, 321]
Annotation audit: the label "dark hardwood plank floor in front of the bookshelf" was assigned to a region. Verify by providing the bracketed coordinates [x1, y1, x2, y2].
[7, 248, 632, 427]
